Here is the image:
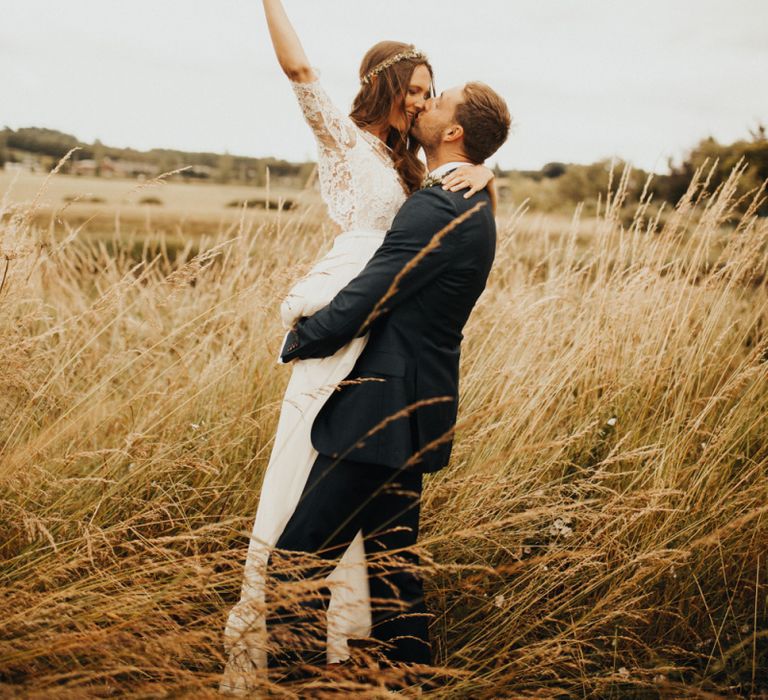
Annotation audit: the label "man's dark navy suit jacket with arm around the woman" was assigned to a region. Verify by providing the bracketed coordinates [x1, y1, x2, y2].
[281, 186, 496, 472]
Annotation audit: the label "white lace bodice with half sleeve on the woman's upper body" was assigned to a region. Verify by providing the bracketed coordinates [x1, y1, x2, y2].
[291, 80, 406, 231]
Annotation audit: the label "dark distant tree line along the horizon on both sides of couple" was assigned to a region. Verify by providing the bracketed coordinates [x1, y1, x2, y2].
[0, 125, 768, 216]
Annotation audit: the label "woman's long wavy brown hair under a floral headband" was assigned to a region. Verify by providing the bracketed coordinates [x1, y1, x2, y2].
[349, 41, 434, 194]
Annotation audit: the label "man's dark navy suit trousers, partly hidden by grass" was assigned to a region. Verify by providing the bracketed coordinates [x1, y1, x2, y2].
[266, 454, 432, 668]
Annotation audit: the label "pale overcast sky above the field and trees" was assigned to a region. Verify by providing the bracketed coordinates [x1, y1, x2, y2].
[0, 0, 768, 170]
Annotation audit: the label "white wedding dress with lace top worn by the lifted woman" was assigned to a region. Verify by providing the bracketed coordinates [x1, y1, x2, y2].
[220, 75, 406, 693]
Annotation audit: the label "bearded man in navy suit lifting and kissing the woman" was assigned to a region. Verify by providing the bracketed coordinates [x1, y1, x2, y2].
[267, 82, 510, 677]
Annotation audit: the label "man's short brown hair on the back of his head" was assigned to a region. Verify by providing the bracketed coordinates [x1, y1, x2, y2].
[455, 82, 512, 163]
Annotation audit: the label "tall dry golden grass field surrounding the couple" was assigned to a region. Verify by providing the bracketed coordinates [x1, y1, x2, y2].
[0, 163, 768, 698]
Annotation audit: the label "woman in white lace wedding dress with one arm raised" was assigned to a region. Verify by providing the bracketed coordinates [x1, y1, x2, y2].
[221, 0, 495, 691]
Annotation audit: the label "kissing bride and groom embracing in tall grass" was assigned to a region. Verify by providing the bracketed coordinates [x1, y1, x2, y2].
[220, 0, 510, 693]
